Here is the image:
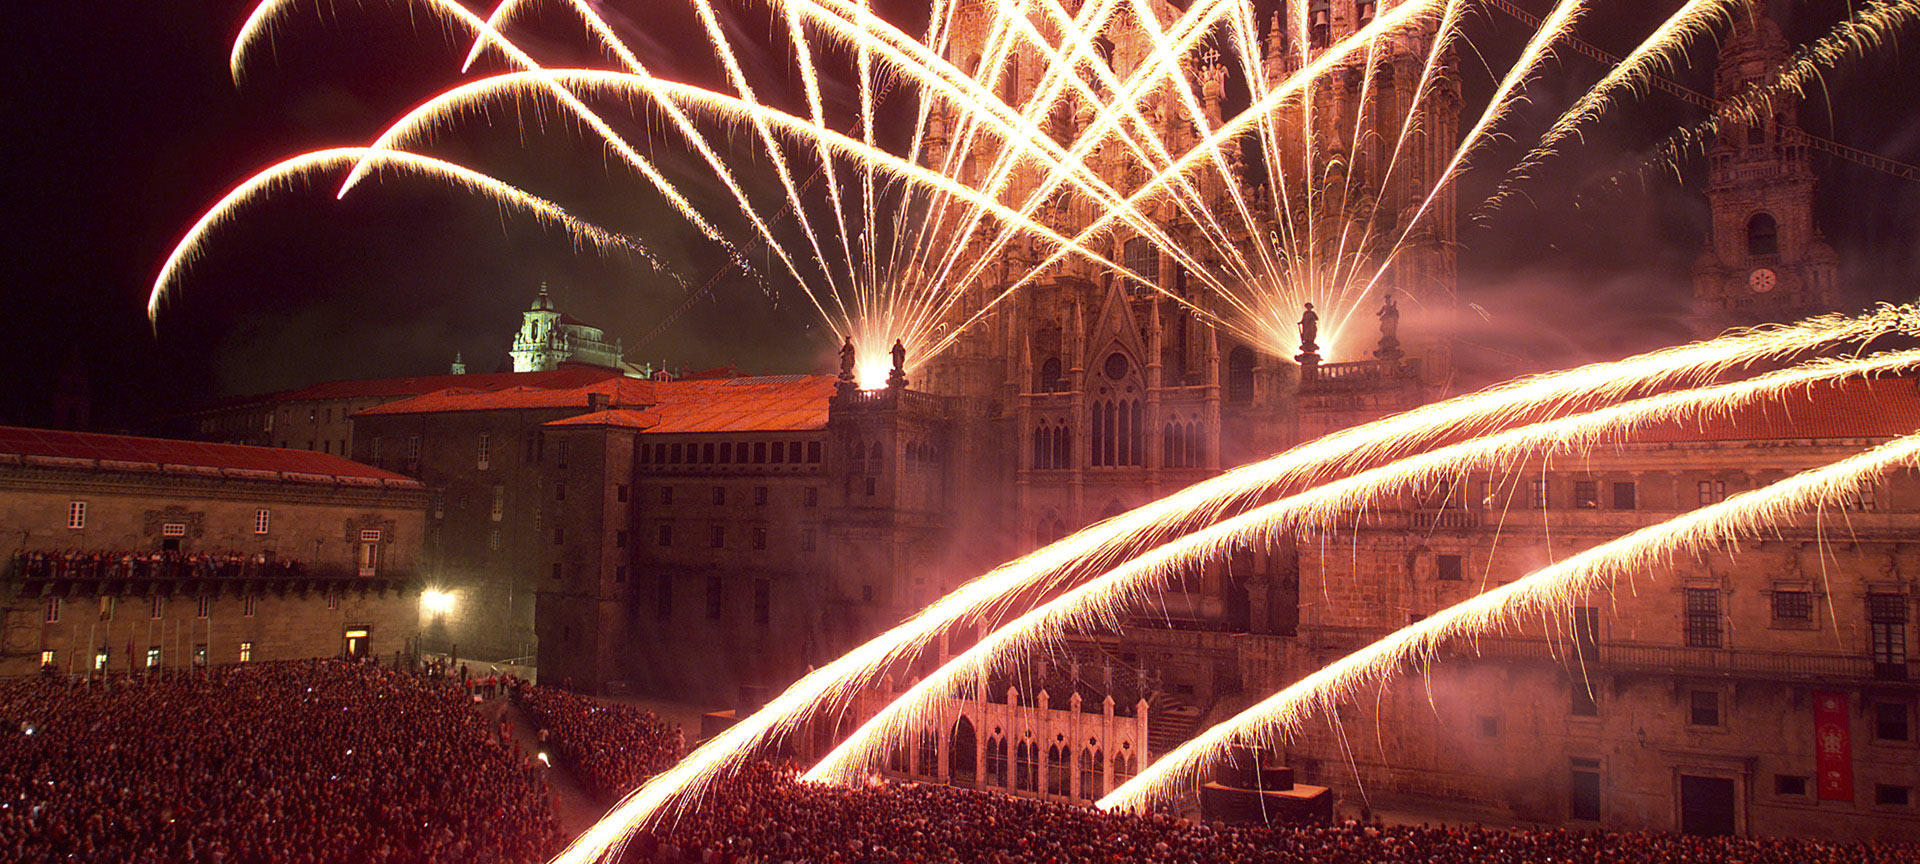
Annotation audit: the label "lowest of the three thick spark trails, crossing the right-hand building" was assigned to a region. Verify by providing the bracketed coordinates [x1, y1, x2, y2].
[1096, 428, 1920, 810]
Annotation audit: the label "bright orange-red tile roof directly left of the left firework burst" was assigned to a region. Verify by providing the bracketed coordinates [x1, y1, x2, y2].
[549, 374, 833, 434]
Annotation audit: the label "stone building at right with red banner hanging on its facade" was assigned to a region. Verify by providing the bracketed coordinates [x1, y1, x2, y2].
[1248, 378, 1920, 839]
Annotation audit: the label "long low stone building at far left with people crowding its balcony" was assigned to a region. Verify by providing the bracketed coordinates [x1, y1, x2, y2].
[0, 428, 426, 676]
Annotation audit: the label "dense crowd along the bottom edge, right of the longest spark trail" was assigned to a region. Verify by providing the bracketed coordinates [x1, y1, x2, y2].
[628, 764, 1920, 864]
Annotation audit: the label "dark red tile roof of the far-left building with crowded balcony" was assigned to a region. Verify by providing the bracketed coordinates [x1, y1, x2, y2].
[0, 426, 420, 488]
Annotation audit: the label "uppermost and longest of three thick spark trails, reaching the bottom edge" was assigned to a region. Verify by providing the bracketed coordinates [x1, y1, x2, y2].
[555, 305, 1920, 864]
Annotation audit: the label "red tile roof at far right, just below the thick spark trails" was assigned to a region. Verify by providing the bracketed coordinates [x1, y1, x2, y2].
[1628, 376, 1920, 444]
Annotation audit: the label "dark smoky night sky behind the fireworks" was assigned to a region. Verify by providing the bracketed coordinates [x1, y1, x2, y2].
[0, 0, 1920, 428]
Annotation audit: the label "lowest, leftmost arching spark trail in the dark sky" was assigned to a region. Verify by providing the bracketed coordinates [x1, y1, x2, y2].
[146, 148, 637, 323]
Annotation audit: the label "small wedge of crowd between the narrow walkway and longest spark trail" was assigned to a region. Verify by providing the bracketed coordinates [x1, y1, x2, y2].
[511, 682, 685, 801]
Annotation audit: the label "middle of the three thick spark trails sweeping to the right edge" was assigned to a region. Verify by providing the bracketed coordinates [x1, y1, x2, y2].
[804, 349, 1920, 783]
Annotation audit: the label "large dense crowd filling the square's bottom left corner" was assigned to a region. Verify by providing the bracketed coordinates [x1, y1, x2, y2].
[0, 660, 561, 864]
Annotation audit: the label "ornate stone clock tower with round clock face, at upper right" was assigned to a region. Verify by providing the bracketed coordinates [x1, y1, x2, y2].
[1693, 2, 1839, 324]
